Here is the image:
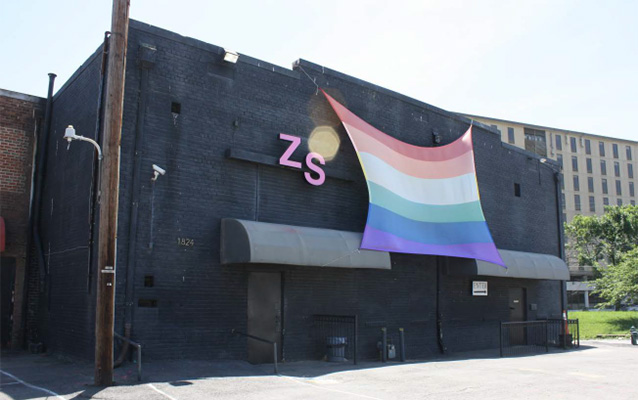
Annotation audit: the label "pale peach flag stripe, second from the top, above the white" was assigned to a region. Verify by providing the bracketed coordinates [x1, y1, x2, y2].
[347, 122, 474, 179]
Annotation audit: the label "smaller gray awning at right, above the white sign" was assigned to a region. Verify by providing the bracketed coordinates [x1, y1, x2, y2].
[476, 250, 569, 281]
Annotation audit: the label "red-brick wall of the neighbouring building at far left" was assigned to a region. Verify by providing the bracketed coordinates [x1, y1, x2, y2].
[0, 89, 45, 348]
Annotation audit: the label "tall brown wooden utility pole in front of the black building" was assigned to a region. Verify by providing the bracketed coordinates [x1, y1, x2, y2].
[95, 0, 129, 386]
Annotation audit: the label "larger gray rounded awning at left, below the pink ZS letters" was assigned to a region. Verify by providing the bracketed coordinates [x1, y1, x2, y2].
[221, 218, 391, 269]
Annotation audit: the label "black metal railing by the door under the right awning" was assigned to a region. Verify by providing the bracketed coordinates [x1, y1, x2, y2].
[499, 319, 580, 357]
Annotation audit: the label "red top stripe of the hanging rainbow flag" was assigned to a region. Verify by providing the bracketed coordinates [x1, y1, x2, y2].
[324, 92, 472, 161]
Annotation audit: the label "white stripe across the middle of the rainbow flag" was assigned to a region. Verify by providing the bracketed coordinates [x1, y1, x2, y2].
[360, 153, 478, 205]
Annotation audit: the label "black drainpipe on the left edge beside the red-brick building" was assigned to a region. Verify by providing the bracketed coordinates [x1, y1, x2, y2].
[31, 73, 57, 293]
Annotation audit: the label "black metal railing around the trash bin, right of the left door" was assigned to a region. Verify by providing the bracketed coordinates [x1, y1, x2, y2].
[312, 315, 359, 364]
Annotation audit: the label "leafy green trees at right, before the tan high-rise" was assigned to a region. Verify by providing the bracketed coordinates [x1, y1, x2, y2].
[565, 206, 638, 306]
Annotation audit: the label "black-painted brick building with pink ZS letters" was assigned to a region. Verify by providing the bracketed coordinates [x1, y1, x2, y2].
[29, 21, 566, 360]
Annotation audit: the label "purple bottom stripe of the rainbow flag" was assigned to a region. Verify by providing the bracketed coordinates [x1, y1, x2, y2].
[361, 226, 507, 268]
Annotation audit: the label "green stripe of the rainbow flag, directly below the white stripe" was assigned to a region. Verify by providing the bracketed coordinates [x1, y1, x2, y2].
[368, 181, 485, 222]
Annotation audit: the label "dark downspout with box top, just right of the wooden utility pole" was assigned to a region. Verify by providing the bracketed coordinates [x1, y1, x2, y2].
[113, 44, 156, 368]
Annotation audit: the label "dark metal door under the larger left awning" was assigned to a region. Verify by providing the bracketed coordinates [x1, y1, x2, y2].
[247, 272, 281, 364]
